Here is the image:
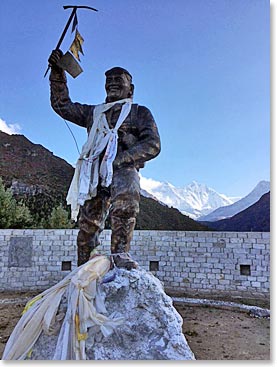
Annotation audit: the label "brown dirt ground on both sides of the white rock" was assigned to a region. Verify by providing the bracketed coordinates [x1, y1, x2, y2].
[0, 293, 270, 360]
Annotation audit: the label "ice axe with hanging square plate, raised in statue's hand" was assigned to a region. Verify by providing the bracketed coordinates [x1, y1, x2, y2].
[44, 5, 98, 78]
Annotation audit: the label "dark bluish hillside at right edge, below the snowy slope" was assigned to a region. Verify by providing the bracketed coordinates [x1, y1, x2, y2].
[201, 192, 270, 232]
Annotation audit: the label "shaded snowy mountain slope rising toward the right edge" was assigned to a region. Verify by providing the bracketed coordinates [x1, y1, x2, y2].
[197, 181, 270, 222]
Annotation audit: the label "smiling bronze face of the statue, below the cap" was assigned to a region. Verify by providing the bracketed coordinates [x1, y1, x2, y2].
[105, 73, 132, 102]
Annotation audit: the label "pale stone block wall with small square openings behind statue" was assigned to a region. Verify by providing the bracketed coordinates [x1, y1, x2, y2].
[0, 229, 270, 295]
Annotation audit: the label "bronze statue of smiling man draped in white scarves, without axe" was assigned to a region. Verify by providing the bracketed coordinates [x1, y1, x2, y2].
[49, 50, 160, 270]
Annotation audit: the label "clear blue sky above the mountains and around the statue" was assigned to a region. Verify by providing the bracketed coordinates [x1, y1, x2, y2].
[0, 0, 270, 196]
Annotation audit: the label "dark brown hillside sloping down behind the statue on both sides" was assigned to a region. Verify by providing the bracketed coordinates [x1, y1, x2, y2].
[0, 131, 207, 231]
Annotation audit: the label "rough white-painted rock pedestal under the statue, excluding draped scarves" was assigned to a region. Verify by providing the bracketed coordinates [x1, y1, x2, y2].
[31, 269, 195, 360]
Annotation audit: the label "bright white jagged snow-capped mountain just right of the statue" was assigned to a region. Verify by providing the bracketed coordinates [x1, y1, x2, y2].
[140, 176, 234, 219]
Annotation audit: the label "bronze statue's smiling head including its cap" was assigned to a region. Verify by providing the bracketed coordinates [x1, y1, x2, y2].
[105, 67, 134, 102]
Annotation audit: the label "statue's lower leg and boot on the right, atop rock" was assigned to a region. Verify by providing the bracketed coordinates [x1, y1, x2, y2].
[111, 216, 138, 270]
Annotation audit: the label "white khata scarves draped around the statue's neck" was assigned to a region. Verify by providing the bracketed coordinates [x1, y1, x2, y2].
[66, 98, 132, 220]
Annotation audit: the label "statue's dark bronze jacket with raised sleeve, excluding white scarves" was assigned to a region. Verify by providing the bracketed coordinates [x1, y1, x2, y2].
[50, 68, 161, 170]
